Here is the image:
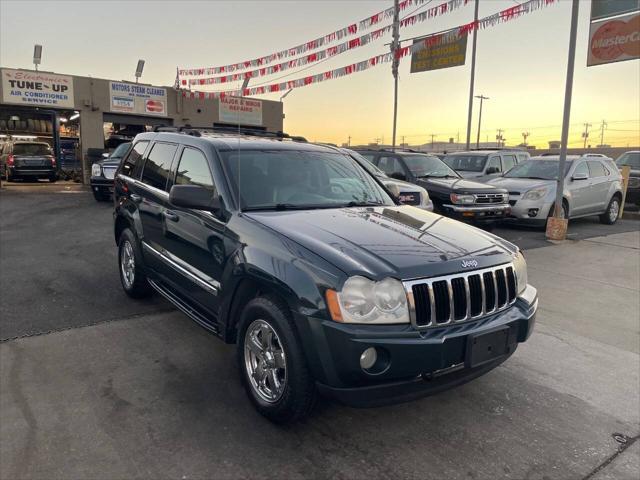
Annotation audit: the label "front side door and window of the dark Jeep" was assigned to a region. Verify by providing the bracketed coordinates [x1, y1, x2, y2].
[161, 146, 228, 314]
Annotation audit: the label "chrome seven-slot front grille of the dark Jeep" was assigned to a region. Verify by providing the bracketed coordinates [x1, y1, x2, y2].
[404, 264, 517, 328]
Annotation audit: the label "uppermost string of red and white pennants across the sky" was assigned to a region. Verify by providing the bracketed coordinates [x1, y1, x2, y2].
[178, 0, 471, 76]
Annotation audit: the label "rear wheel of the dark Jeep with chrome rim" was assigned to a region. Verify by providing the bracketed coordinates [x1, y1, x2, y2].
[118, 228, 151, 298]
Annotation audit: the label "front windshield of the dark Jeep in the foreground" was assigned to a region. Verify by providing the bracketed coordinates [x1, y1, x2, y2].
[220, 150, 394, 210]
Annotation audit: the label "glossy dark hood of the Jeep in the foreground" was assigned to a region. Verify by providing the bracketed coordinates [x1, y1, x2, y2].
[245, 206, 517, 280]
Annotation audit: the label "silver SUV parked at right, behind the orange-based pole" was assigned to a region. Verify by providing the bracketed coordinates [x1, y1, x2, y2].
[488, 155, 622, 225]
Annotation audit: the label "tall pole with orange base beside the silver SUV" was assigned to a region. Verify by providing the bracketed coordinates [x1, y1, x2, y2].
[546, 0, 580, 240]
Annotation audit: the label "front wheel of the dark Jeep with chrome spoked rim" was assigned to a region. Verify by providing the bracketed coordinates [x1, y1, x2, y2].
[236, 296, 316, 424]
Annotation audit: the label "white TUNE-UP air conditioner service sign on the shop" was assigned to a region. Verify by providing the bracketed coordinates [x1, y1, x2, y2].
[0, 68, 75, 108]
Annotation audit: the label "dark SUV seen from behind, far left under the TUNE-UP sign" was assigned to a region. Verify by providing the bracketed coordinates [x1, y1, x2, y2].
[0, 140, 58, 182]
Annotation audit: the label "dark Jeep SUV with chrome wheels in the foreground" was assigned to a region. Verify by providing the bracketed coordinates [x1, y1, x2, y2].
[114, 129, 538, 422]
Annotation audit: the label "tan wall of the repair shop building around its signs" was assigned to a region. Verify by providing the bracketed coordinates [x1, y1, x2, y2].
[0, 70, 283, 184]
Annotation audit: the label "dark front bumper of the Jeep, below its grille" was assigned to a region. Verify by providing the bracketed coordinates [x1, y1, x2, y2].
[301, 286, 538, 407]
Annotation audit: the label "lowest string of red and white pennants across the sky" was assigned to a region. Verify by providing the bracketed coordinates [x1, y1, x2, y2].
[182, 0, 559, 99]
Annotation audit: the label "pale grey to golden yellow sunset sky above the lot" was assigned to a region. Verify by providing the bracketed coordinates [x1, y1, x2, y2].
[0, 0, 640, 147]
